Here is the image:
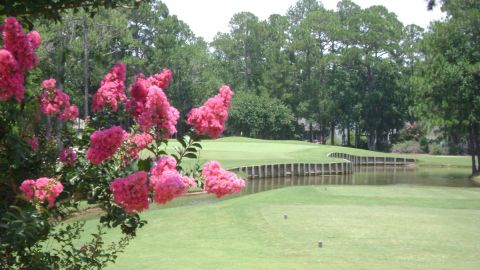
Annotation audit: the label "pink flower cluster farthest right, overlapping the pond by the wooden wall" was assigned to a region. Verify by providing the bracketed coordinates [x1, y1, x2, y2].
[202, 161, 245, 198]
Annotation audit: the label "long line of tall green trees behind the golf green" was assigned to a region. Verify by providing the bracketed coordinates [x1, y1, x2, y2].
[25, 0, 480, 161]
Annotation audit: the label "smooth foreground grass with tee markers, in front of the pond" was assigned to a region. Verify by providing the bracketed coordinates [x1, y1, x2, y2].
[78, 186, 480, 270]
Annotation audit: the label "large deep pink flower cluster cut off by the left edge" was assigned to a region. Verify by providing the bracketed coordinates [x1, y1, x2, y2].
[0, 17, 41, 102]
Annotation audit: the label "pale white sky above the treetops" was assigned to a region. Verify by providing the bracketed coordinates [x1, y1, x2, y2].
[162, 0, 444, 41]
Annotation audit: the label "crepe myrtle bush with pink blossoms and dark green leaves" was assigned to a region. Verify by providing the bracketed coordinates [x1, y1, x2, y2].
[0, 17, 245, 269]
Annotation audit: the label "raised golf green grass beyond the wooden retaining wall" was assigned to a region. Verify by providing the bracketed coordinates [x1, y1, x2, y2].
[185, 137, 470, 168]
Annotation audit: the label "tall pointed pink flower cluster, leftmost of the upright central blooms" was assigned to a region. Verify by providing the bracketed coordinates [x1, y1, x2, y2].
[92, 61, 127, 112]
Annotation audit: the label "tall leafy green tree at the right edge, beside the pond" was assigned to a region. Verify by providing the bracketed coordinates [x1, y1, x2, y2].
[416, 0, 480, 174]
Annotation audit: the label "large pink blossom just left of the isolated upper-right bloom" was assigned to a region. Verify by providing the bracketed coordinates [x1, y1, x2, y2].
[138, 86, 180, 138]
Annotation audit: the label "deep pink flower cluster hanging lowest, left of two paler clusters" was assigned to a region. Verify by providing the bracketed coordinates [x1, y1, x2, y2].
[110, 171, 149, 213]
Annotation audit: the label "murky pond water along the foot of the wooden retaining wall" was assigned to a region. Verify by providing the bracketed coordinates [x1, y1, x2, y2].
[243, 166, 477, 193]
